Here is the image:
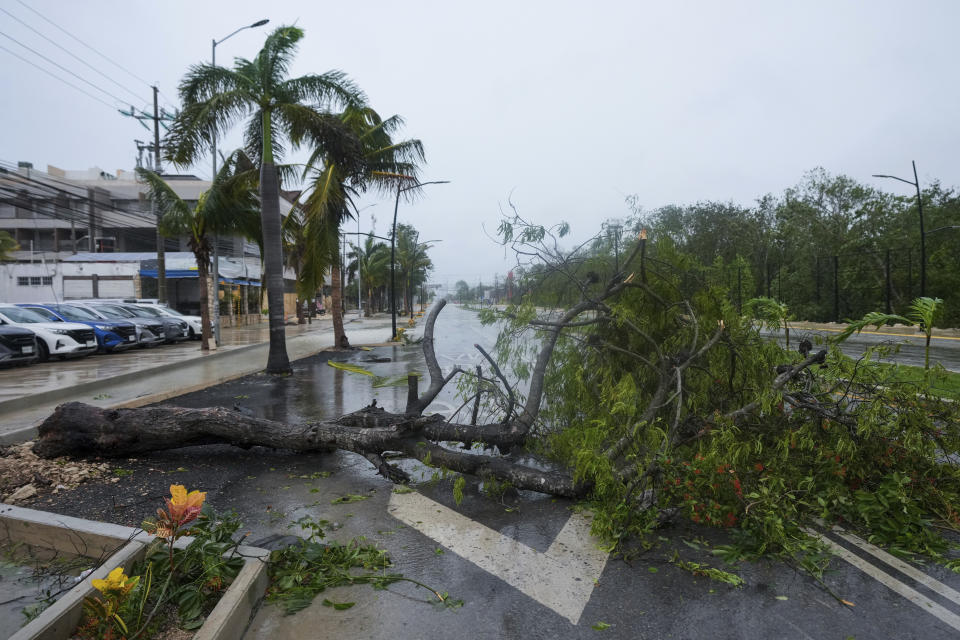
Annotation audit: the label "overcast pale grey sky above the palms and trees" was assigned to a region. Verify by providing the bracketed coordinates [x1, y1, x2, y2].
[0, 0, 960, 285]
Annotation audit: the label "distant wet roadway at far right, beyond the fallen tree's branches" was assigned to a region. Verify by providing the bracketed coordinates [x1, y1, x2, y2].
[764, 329, 960, 372]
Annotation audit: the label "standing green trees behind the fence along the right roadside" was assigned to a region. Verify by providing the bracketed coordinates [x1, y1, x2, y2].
[628, 169, 960, 326]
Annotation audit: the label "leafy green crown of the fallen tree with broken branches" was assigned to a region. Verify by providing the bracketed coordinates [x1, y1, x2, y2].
[485, 221, 960, 573]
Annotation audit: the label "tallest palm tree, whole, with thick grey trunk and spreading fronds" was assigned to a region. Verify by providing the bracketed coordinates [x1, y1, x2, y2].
[167, 26, 364, 373]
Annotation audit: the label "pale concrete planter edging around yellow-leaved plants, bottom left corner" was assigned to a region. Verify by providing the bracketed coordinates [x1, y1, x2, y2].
[0, 505, 270, 640]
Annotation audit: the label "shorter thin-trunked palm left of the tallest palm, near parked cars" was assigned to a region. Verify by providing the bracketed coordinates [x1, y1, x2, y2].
[137, 151, 260, 351]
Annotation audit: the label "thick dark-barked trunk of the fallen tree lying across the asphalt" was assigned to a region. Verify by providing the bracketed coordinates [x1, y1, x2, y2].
[33, 402, 576, 498]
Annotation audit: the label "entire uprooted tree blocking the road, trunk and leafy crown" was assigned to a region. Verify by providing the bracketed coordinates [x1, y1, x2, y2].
[34, 214, 960, 559]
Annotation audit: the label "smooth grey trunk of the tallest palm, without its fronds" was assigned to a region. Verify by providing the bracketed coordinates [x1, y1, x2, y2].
[260, 156, 293, 374]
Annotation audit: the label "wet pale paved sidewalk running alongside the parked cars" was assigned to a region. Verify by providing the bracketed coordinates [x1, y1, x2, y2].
[0, 314, 406, 444]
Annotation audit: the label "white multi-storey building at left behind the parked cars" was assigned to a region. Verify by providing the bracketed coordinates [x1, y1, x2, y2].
[0, 163, 293, 313]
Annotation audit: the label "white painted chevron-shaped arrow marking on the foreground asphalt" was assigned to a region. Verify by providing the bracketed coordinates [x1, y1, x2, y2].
[387, 493, 609, 624]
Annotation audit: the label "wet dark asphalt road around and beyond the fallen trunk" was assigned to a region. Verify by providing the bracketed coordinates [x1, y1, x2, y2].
[24, 308, 960, 640]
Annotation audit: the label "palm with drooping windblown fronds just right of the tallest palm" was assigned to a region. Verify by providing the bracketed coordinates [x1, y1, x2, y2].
[304, 105, 424, 348]
